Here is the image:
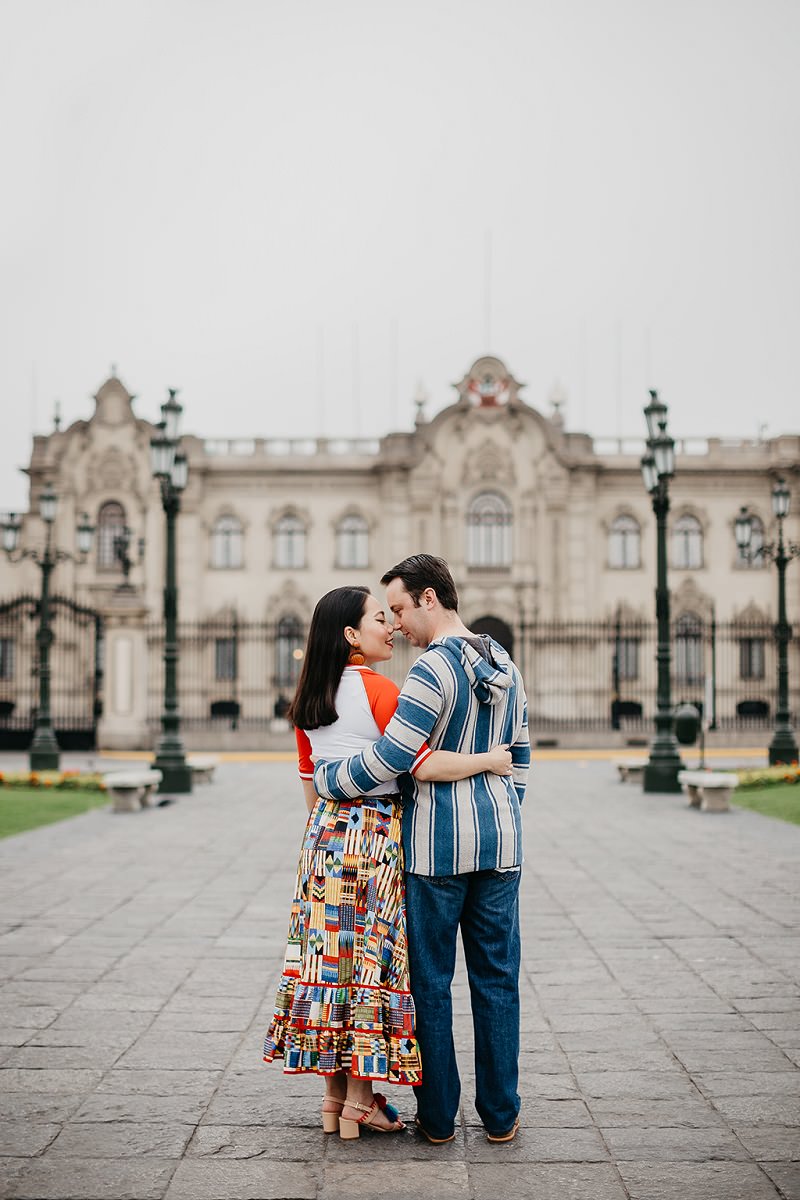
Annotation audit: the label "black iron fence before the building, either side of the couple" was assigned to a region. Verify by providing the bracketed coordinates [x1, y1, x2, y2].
[148, 617, 800, 733]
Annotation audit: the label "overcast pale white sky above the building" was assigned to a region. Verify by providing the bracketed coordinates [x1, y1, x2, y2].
[0, 0, 800, 509]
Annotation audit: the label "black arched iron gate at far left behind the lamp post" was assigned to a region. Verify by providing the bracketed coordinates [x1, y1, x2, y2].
[0, 595, 103, 750]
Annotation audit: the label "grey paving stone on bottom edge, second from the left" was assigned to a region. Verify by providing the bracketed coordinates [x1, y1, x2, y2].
[166, 1158, 319, 1200]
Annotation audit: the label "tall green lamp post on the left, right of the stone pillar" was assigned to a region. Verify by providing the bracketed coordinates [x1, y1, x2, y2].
[150, 388, 192, 793]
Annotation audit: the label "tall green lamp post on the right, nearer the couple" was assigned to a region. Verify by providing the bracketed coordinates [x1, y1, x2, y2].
[642, 391, 681, 792]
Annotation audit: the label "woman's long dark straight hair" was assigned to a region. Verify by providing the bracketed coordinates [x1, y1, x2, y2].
[287, 587, 369, 730]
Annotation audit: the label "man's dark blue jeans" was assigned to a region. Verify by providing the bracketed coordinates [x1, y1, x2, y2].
[405, 870, 521, 1138]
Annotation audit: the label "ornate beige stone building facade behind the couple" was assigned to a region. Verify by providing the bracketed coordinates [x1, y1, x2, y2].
[0, 358, 800, 745]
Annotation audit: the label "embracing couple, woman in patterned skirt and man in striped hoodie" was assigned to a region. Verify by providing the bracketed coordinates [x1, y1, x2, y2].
[264, 554, 530, 1145]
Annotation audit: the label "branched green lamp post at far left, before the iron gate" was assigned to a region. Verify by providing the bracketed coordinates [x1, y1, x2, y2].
[2, 484, 95, 770]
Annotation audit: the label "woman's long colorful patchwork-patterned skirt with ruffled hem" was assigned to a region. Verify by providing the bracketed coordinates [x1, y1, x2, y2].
[264, 796, 422, 1084]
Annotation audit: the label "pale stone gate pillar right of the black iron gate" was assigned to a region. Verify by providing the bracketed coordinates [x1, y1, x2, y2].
[97, 586, 154, 750]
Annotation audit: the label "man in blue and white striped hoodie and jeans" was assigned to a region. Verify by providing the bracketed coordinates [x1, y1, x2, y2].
[314, 554, 530, 1144]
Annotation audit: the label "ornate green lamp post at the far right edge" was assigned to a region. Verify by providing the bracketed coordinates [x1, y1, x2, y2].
[736, 479, 800, 764]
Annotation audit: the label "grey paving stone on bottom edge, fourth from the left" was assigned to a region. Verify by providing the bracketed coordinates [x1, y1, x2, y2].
[469, 1161, 633, 1200]
